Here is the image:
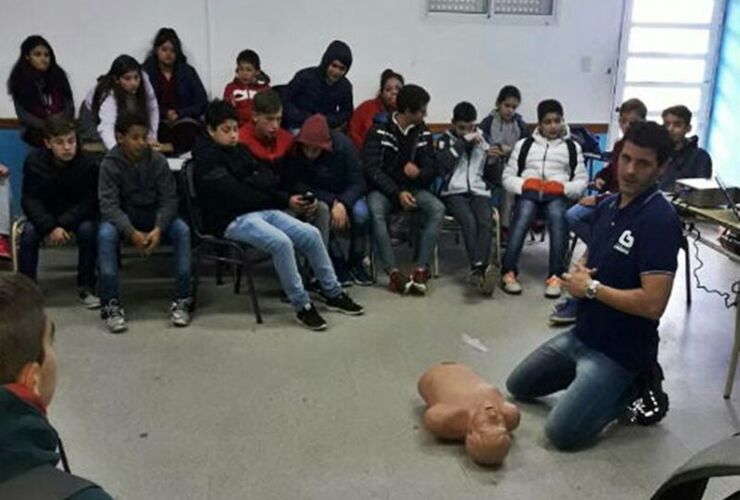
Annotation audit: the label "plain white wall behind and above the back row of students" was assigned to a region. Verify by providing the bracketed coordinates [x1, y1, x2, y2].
[0, 0, 623, 123]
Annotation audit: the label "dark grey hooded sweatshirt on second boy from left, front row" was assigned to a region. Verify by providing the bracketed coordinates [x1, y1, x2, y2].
[98, 146, 178, 237]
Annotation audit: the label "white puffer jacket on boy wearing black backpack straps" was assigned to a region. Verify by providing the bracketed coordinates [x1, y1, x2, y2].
[503, 125, 588, 200]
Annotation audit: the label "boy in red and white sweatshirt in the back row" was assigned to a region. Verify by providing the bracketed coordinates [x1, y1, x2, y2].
[224, 49, 270, 127]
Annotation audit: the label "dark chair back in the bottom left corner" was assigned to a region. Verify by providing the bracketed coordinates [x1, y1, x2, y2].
[0, 465, 98, 500]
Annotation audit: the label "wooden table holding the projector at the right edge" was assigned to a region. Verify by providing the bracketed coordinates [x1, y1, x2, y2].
[672, 200, 740, 399]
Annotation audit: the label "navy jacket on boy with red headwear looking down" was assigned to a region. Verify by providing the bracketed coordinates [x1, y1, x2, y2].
[291, 131, 366, 212]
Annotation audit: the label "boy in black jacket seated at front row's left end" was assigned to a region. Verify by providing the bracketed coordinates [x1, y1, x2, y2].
[18, 115, 100, 309]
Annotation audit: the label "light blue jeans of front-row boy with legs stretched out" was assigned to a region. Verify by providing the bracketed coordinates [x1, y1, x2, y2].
[224, 210, 342, 310]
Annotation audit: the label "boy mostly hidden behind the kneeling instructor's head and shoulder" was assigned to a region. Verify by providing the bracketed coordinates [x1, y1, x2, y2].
[549, 98, 647, 326]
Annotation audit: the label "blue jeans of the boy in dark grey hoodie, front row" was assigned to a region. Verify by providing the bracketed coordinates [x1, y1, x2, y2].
[98, 217, 192, 304]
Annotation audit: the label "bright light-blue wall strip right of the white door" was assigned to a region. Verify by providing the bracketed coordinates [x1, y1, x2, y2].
[707, 0, 740, 186]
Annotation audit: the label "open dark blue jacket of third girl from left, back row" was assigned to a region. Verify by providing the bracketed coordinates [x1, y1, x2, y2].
[143, 57, 208, 120]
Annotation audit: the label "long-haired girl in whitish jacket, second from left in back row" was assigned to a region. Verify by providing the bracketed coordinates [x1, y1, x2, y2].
[80, 54, 159, 150]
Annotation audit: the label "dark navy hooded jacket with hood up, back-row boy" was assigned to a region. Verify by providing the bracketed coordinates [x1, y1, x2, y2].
[283, 40, 353, 129]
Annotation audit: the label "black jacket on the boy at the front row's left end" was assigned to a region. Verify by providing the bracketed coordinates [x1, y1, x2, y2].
[21, 148, 98, 235]
